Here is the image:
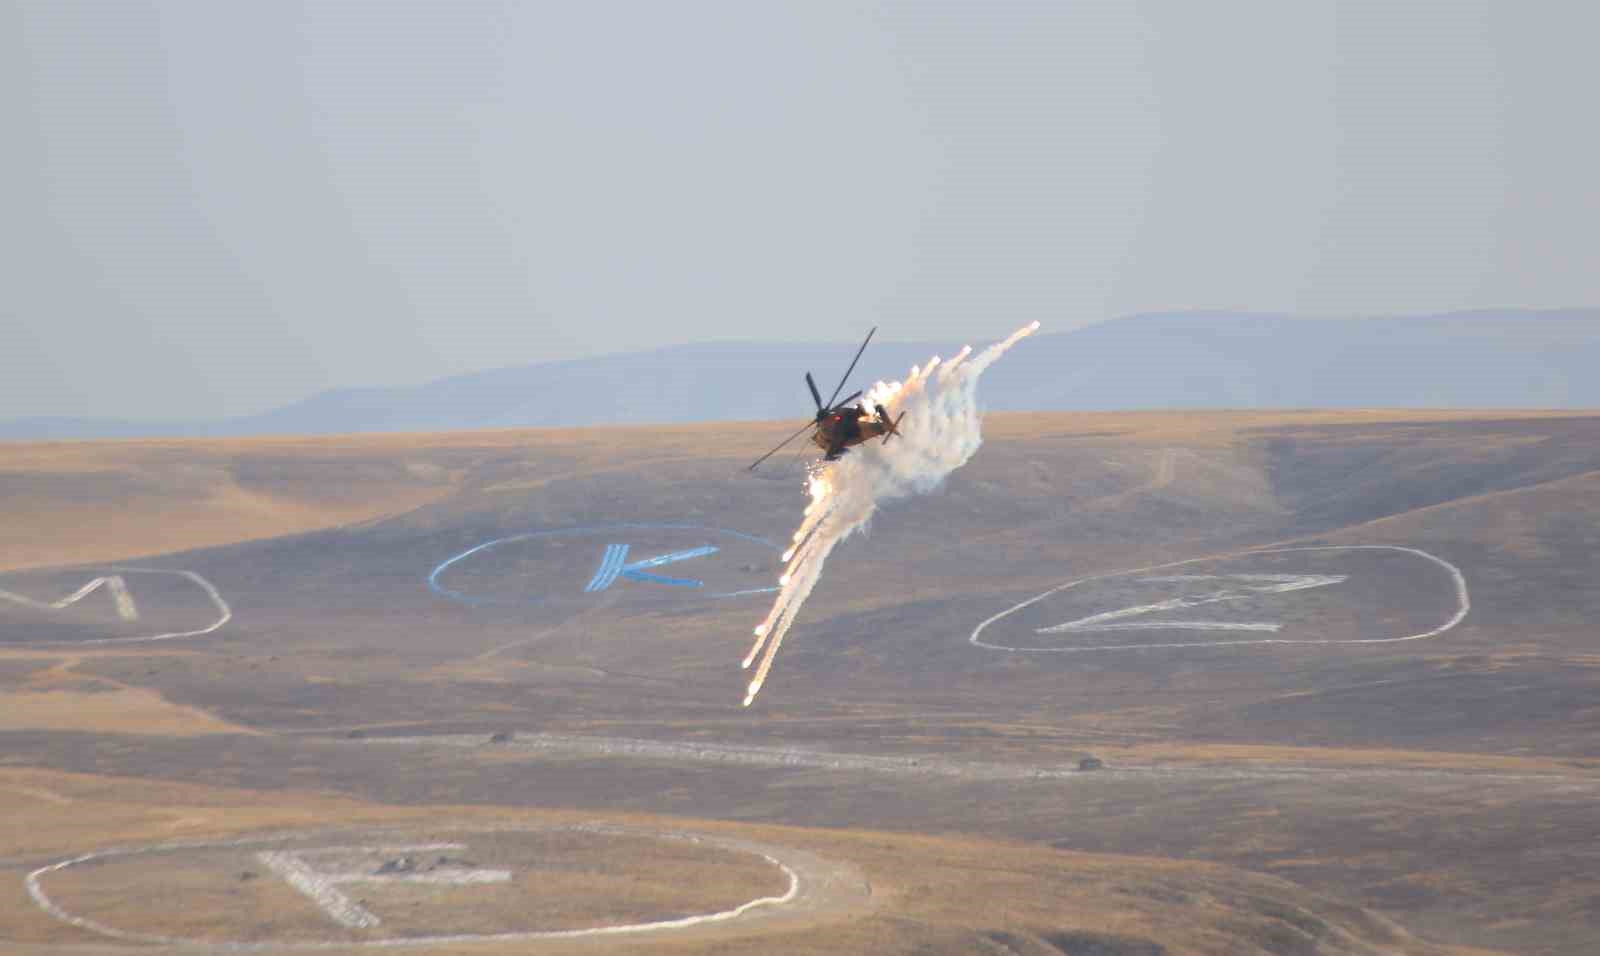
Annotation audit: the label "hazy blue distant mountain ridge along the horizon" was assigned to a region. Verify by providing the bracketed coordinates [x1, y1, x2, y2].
[12, 309, 1600, 440]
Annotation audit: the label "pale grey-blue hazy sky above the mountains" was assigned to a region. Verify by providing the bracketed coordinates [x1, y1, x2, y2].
[0, 0, 1600, 419]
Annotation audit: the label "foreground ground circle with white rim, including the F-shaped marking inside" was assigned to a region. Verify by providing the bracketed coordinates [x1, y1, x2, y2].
[24, 823, 866, 951]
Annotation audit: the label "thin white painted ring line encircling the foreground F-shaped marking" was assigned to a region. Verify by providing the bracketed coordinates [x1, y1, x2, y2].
[22, 825, 814, 953]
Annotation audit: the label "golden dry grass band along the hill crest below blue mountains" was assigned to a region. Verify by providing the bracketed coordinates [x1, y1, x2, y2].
[0, 409, 1579, 571]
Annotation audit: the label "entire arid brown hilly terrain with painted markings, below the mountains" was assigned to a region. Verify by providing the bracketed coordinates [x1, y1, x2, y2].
[0, 411, 1600, 956]
